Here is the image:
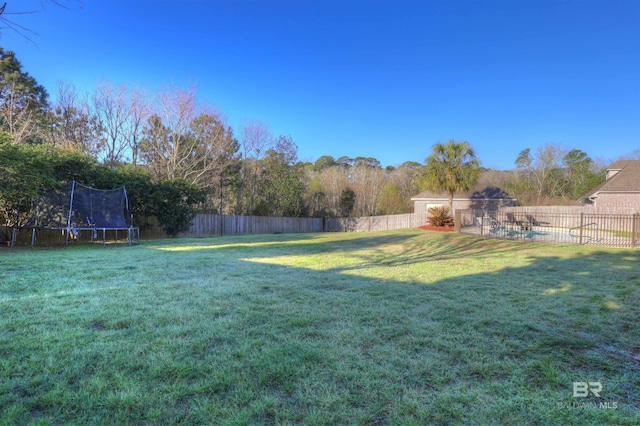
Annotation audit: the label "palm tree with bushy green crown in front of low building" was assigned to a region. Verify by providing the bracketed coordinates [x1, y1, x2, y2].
[425, 140, 480, 212]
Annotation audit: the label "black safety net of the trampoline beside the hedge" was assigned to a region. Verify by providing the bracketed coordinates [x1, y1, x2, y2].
[21, 181, 129, 229]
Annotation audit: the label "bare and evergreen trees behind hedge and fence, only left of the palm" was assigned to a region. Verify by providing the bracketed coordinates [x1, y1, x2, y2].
[0, 48, 422, 230]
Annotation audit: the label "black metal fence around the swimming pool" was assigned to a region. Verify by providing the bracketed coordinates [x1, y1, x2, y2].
[456, 210, 640, 248]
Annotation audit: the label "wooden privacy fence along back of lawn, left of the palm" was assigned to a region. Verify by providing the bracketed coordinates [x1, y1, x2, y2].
[141, 213, 426, 239]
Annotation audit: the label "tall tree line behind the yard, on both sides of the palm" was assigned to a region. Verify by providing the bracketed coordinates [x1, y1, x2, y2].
[0, 47, 624, 240]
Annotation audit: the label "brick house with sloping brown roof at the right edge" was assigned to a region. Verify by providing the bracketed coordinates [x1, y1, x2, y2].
[580, 160, 640, 213]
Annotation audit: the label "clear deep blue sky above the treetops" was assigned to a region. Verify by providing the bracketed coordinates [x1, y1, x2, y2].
[0, 0, 640, 169]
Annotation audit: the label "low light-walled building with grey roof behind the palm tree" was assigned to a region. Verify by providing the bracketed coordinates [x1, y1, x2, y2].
[411, 185, 516, 215]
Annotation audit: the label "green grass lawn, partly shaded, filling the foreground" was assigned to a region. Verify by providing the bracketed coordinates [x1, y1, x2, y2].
[0, 230, 640, 425]
